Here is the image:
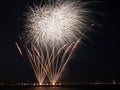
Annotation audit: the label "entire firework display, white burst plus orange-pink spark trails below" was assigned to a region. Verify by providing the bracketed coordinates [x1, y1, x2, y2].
[16, 0, 98, 85]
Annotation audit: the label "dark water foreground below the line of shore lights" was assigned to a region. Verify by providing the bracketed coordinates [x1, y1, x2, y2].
[0, 85, 120, 90]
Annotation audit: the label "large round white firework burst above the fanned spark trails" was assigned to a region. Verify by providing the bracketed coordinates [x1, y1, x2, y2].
[22, 0, 94, 47]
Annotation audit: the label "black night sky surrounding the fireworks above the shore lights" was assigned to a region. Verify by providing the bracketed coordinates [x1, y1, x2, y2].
[0, 0, 120, 82]
